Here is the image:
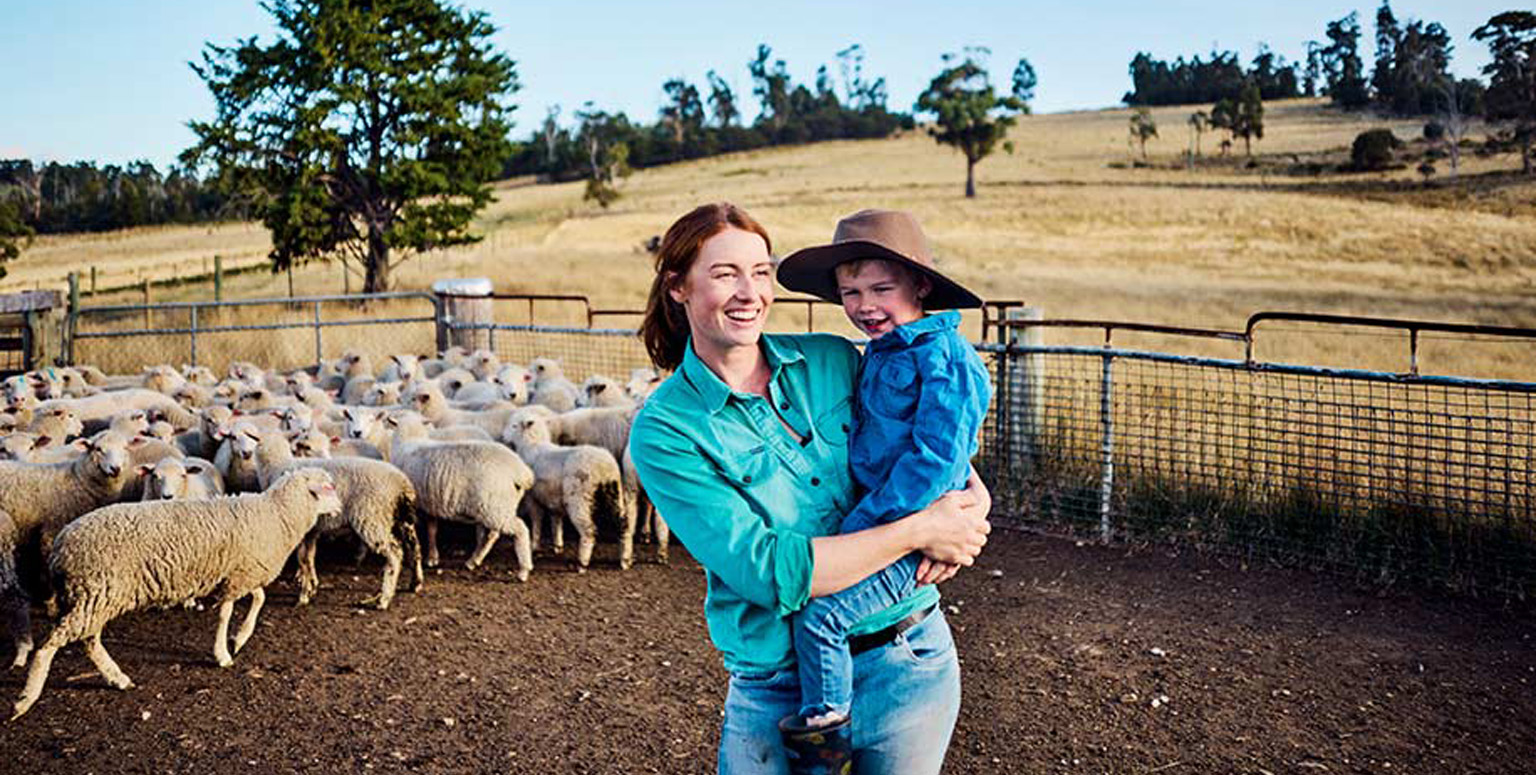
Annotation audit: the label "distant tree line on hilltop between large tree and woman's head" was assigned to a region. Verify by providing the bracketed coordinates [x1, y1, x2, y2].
[504, 45, 914, 196]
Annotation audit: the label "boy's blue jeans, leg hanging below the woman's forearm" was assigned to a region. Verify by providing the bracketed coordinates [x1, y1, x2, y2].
[793, 551, 932, 718]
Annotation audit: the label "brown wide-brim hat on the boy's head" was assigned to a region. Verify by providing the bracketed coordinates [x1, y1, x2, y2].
[779, 210, 982, 310]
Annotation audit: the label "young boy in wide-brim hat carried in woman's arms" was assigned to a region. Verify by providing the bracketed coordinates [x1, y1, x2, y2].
[779, 210, 991, 770]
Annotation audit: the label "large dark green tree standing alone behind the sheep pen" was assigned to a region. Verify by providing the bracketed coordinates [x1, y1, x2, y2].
[183, 0, 518, 293]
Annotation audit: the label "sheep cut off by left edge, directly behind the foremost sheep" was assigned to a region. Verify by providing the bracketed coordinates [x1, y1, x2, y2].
[0, 433, 129, 668]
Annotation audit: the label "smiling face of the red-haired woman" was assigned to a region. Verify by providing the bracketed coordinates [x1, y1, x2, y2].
[670, 227, 773, 355]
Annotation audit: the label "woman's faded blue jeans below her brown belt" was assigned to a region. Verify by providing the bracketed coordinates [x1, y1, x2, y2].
[719, 611, 960, 775]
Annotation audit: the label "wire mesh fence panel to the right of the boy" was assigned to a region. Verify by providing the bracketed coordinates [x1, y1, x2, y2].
[983, 345, 1536, 599]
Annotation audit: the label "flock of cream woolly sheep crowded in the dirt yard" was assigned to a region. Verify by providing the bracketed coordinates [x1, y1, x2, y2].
[0, 348, 668, 718]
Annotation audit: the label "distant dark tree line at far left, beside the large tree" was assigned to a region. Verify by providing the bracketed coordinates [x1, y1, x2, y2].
[0, 160, 246, 235]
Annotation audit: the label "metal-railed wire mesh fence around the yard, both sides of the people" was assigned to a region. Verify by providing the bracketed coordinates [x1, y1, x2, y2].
[54, 293, 1536, 599]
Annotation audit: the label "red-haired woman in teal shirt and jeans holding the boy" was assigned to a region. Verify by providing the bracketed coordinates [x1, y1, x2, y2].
[630, 204, 991, 775]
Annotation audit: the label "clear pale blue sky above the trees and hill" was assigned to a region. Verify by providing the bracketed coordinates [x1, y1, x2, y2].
[0, 0, 1516, 167]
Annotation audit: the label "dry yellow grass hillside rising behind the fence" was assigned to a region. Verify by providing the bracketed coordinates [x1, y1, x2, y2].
[12, 100, 1536, 379]
